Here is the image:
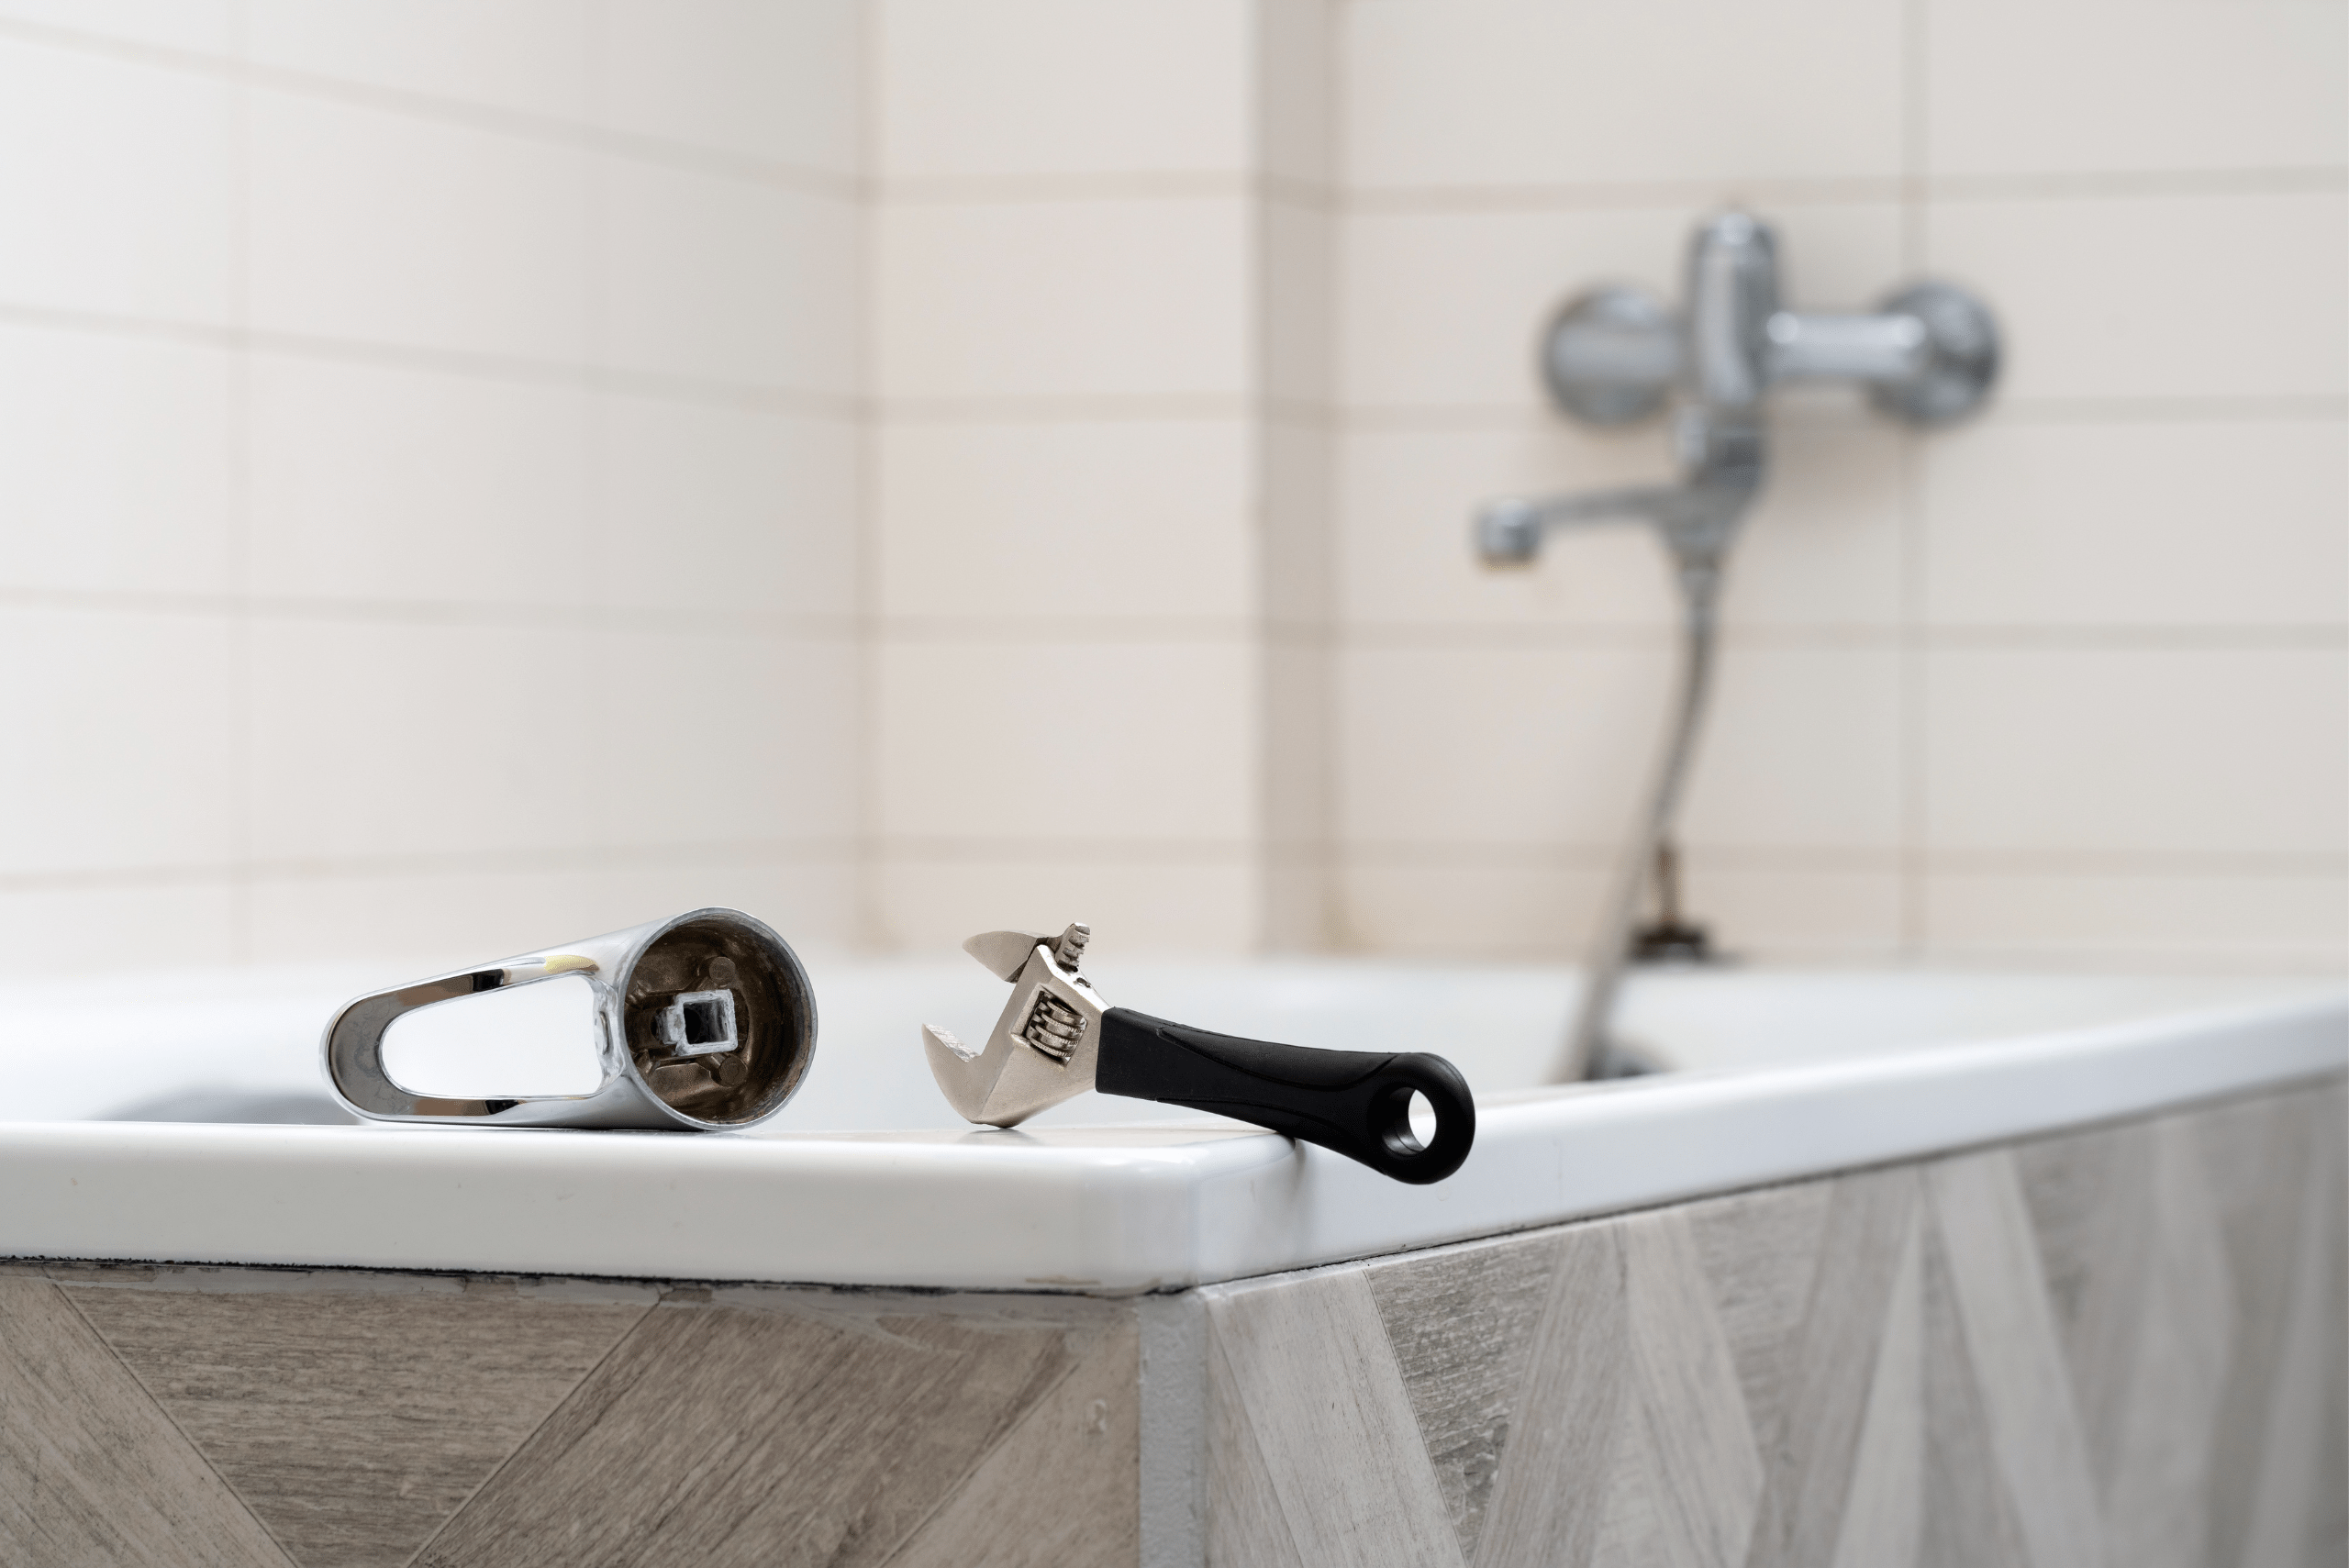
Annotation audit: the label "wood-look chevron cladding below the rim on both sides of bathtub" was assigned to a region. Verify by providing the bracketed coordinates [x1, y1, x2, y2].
[0, 1084, 2349, 1568]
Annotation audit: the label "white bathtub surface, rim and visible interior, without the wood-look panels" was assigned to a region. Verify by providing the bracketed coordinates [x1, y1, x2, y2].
[0, 962, 2349, 1291]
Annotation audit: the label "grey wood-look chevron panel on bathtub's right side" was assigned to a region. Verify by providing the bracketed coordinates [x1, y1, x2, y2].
[1203, 1087, 2349, 1568]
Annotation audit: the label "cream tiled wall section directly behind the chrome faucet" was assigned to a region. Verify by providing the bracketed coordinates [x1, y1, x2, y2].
[1330, 0, 2349, 964]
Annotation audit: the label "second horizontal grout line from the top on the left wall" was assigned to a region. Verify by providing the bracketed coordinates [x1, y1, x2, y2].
[0, 297, 864, 420]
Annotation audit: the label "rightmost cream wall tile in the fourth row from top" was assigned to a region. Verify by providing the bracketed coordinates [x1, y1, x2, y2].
[1926, 646, 2349, 854]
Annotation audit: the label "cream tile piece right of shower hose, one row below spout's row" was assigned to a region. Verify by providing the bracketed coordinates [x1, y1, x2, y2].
[1681, 643, 1903, 850]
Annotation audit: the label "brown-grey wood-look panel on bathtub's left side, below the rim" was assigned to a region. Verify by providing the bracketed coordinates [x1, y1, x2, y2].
[0, 1268, 1140, 1568]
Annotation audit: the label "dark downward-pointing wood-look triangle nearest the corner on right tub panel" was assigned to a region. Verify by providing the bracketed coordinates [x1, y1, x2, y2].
[1367, 1237, 1557, 1561]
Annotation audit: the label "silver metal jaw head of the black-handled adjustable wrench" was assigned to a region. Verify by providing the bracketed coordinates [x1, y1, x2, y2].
[921, 932, 1108, 1127]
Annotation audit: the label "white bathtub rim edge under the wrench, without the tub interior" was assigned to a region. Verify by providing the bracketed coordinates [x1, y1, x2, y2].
[0, 997, 2349, 1294]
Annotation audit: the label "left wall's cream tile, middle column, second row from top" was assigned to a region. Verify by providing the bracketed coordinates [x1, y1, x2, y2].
[249, 92, 592, 364]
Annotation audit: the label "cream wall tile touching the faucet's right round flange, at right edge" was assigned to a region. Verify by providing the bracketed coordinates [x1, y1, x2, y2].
[1926, 193, 2349, 399]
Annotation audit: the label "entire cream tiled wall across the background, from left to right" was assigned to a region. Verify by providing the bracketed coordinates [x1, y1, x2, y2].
[0, 0, 2349, 967]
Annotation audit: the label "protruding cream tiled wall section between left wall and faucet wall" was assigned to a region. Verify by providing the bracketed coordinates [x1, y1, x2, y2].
[872, 0, 1330, 951]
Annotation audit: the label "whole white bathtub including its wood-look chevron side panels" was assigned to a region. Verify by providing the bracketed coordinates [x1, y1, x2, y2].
[0, 960, 2349, 1568]
